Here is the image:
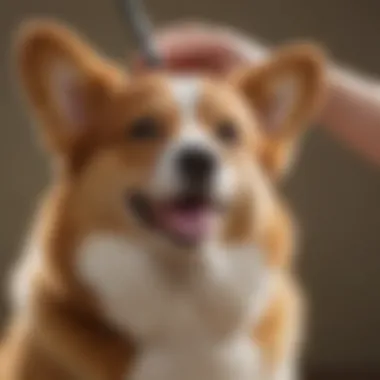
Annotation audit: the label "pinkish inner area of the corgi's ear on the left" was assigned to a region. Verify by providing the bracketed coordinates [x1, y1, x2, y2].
[52, 63, 87, 129]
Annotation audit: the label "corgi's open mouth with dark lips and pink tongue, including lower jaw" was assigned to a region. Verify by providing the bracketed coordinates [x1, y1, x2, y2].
[127, 192, 227, 251]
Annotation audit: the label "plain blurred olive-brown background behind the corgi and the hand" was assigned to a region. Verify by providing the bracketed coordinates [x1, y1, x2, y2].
[0, 0, 380, 380]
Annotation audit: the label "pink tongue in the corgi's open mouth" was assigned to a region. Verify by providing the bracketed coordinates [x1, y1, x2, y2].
[162, 207, 211, 240]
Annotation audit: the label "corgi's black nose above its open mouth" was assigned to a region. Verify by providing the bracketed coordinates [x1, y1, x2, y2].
[178, 147, 216, 185]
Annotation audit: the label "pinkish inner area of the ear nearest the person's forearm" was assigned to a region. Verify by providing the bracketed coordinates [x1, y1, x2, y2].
[263, 80, 296, 134]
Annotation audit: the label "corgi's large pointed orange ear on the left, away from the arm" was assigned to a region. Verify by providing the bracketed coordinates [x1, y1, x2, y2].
[16, 21, 125, 154]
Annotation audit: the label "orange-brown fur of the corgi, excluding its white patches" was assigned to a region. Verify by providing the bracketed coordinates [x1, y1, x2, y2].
[0, 18, 323, 380]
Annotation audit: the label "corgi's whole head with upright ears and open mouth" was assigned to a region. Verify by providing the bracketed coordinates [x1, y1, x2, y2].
[17, 23, 323, 256]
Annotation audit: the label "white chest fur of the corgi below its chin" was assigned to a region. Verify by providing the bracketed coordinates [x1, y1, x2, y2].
[78, 235, 267, 380]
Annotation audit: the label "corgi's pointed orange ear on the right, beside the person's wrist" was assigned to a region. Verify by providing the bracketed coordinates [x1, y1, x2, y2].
[232, 45, 325, 178]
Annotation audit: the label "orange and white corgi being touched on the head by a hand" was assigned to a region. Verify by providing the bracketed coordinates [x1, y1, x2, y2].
[0, 20, 324, 380]
